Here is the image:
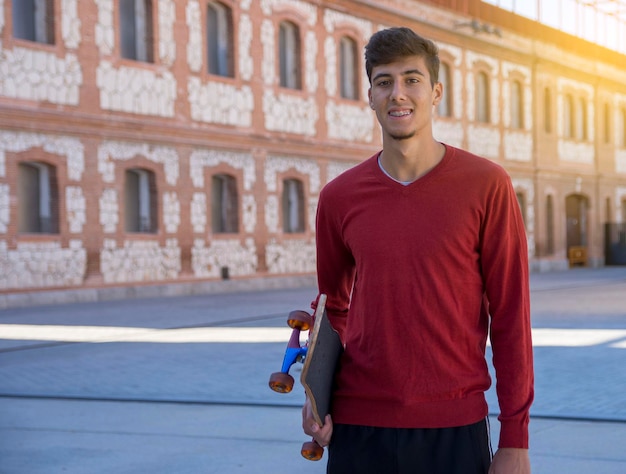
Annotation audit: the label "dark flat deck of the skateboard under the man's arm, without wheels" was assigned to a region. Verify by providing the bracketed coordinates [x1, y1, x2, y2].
[300, 294, 343, 426]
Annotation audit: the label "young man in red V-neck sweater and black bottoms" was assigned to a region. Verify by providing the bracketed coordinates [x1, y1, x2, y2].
[303, 28, 533, 474]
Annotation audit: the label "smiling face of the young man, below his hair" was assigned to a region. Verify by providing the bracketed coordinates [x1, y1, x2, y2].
[368, 56, 443, 140]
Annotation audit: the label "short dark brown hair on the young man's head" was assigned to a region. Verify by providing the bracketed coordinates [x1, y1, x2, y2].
[365, 27, 439, 85]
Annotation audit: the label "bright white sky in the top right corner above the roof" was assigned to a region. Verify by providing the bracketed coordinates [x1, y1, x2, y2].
[483, 0, 626, 54]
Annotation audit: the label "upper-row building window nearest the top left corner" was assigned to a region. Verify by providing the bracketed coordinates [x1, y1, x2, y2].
[11, 0, 54, 44]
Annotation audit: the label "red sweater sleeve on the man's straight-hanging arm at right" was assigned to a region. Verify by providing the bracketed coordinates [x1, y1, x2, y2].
[481, 171, 534, 448]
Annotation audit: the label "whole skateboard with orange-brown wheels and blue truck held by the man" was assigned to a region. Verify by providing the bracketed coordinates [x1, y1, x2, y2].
[269, 294, 343, 461]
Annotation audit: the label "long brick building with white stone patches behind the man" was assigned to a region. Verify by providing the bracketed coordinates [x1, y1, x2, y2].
[0, 0, 626, 294]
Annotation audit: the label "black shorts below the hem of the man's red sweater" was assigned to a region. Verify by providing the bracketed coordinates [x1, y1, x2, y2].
[326, 420, 492, 474]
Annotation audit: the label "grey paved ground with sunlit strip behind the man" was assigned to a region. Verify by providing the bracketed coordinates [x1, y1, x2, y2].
[0, 267, 626, 474]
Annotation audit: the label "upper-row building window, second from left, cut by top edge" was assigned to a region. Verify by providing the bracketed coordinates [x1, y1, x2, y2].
[119, 0, 154, 63]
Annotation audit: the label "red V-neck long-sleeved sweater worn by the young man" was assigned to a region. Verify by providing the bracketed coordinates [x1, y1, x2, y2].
[316, 146, 533, 448]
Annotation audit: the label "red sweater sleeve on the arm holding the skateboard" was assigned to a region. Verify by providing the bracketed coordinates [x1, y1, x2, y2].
[313, 187, 355, 340]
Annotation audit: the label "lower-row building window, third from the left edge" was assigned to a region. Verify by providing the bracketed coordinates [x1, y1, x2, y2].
[211, 174, 239, 234]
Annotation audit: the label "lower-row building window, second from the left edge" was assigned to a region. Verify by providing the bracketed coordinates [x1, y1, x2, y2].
[124, 168, 157, 233]
